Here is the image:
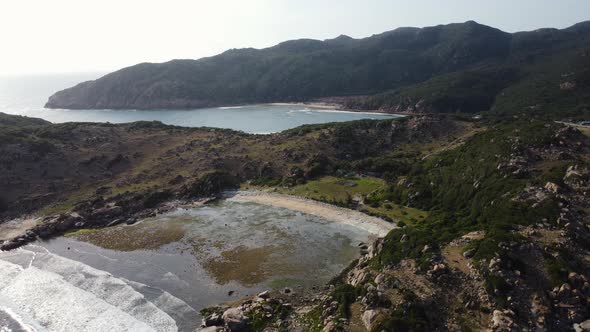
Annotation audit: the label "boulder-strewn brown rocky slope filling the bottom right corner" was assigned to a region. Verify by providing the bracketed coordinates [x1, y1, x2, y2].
[192, 122, 590, 332]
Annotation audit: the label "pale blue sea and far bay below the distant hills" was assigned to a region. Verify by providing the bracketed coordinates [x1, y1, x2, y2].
[0, 74, 395, 134]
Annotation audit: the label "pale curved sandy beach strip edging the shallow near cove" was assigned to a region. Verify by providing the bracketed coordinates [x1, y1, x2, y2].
[228, 191, 397, 237]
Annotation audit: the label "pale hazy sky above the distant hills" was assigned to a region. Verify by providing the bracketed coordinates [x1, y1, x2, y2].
[0, 0, 590, 75]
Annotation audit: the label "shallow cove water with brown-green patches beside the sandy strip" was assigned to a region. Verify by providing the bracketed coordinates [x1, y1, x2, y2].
[31, 201, 369, 325]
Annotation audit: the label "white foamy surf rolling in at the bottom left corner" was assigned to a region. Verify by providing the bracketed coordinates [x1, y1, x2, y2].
[0, 246, 197, 332]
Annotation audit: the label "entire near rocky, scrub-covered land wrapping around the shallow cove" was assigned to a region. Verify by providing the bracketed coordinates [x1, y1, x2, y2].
[0, 115, 590, 331]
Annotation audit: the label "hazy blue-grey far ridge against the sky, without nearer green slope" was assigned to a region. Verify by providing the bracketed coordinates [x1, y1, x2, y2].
[46, 21, 590, 109]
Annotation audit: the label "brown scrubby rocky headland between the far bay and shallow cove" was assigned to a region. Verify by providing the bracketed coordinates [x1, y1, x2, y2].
[0, 113, 471, 248]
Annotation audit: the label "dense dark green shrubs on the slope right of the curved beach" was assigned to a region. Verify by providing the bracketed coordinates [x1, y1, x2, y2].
[369, 121, 569, 272]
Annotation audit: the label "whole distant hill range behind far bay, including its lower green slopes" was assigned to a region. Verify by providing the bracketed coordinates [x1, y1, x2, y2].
[46, 21, 590, 118]
